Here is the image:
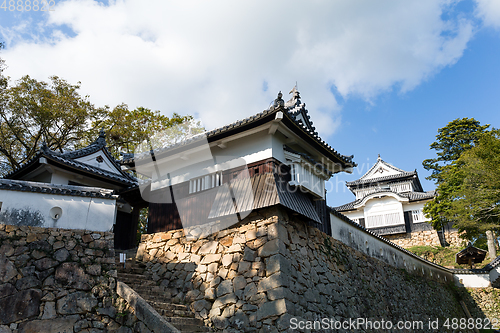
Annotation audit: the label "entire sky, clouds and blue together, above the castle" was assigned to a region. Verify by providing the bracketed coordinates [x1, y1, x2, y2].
[0, 0, 500, 206]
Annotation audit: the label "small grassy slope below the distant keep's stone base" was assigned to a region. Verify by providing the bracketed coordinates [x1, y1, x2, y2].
[407, 246, 489, 269]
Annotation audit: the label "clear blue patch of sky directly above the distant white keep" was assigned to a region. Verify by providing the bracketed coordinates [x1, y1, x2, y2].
[329, 29, 500, 205]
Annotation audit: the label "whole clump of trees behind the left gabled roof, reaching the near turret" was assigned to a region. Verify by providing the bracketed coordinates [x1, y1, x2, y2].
[0, 73, 202, 175]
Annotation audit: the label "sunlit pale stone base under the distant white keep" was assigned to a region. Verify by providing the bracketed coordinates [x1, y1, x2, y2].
[382, 230, 465, 249]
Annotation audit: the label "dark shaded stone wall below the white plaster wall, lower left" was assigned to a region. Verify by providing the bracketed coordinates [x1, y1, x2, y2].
[0, 224, 154, 333]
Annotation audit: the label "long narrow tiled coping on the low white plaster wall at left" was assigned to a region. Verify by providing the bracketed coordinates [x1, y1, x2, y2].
[0, 179, 118, 199]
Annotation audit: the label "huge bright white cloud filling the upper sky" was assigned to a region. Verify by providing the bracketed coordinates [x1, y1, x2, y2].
[2, 0, 472, 135]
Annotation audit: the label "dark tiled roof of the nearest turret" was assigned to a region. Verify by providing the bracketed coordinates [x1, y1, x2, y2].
[121, 92, 356, 167]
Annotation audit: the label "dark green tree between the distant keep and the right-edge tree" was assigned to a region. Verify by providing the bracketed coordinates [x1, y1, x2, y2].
[422, 118, 490, 230]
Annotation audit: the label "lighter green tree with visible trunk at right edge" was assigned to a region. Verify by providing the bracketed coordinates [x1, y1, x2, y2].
[443, 130, 500, 259]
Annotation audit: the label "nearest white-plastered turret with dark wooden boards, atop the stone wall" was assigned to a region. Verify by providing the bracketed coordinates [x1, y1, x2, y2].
[122, 88, 356, 234]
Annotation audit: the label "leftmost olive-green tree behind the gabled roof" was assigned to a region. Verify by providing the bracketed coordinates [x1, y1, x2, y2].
[0, 76, 105, 173]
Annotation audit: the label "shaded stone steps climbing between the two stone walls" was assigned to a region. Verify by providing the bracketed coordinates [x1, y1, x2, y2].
[116, 254, 212, 333]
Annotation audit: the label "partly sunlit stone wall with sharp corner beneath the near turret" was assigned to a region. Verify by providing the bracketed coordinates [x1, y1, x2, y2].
[138, 208, 480, 332]
